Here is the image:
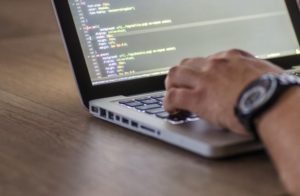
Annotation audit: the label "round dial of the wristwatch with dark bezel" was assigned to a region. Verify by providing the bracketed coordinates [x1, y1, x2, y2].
[239, 75, 278, 115]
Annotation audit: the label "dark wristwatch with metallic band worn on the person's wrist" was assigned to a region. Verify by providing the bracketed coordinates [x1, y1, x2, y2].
[234, 73, 300, 139]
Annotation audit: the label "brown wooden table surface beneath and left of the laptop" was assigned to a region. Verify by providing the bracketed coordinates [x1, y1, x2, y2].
[0, 0, 285, 196]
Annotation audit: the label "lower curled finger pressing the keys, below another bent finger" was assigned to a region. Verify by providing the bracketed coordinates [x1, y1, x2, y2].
[164, 88, 198, 113]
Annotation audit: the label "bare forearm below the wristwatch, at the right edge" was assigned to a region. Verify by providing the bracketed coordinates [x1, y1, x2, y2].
[257, 87, 300, 195]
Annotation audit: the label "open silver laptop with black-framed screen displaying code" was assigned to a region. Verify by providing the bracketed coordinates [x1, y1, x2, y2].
[53, 0, 300, 158]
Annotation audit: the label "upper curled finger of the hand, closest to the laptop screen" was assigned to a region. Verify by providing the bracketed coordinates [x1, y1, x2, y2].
[165, 66, 201, 90]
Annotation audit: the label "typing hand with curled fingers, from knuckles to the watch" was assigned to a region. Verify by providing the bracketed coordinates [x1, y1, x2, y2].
[164, 49, 283, 134]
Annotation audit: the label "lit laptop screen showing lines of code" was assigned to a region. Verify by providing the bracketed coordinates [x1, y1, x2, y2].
[69, 0, 300, 85]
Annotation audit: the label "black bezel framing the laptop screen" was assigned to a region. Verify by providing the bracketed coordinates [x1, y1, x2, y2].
[53, 0, 300, 108]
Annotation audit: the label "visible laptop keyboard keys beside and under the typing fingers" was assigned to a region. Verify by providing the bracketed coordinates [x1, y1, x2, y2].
[119, 93, 199, 124]
